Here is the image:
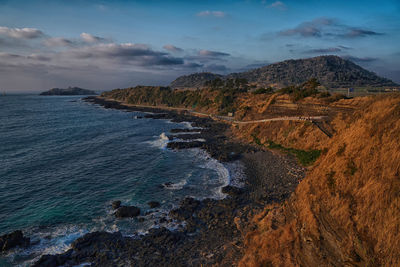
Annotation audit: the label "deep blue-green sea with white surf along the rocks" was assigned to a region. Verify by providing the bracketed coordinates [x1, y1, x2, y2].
[0, 95, 228, 265]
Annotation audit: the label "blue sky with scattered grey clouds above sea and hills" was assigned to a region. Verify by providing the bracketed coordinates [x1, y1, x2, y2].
[0, 0, 400, 93]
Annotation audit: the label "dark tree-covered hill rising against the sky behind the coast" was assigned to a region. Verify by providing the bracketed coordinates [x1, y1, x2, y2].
[171, 56, 398, 88]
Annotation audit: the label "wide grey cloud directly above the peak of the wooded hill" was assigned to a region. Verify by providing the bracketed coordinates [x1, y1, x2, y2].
[279, 17, 383, 38]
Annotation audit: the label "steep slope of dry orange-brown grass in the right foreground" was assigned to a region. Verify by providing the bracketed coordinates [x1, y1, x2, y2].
[239, 95, 400, 266]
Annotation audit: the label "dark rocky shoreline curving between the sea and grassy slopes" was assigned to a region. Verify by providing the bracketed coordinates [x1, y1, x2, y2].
[28, 97, 305, 266]
